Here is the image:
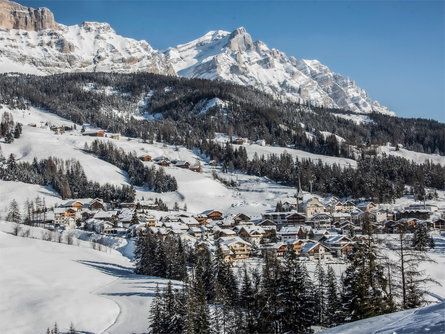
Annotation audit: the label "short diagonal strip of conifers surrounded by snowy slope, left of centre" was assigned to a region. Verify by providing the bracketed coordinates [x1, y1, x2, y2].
[85, 139, 178, 193]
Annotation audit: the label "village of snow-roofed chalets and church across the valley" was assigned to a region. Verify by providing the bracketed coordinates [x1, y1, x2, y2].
[39, 193, 445, 262]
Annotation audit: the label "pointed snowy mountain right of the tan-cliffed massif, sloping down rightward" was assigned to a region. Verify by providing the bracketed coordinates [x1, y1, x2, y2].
[165, 27, 392, 114]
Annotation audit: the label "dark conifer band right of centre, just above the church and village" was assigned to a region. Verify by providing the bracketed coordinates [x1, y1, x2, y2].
[201, 141, 445, 203]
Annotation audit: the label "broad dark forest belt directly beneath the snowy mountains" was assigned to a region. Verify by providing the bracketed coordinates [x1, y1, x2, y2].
[0, 73, 445, 157]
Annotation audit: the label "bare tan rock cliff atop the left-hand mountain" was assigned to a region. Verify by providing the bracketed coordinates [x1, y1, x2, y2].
[0, 1, 59, 31]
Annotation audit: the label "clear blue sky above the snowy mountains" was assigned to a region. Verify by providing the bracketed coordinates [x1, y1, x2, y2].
[17, 0, 445, 122]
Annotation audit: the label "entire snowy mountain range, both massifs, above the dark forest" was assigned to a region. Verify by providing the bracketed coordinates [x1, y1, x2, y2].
[0, 1, 394, 114]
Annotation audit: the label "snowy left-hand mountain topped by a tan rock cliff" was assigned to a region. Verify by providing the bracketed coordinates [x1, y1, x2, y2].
[0, 2, 176, 75]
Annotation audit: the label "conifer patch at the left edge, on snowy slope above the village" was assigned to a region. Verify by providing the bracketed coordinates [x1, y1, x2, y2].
[0, 154, 135, 202]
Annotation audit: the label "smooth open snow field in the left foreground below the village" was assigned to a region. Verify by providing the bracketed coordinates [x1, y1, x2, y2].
[0, 222, 173, 334]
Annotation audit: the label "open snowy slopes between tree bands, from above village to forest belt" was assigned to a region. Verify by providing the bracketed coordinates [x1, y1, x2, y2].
[0, 106, 445, 218]
